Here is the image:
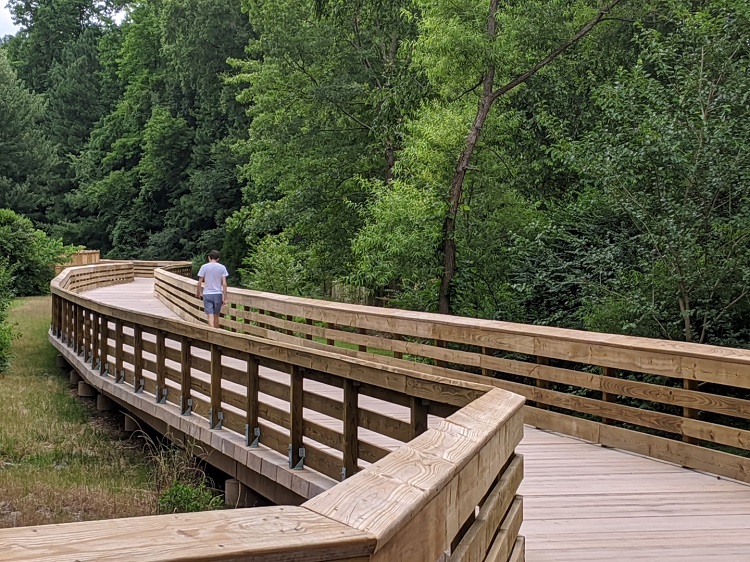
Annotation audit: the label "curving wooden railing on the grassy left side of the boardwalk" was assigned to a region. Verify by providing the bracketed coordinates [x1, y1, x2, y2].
[13, 265, 524, 562]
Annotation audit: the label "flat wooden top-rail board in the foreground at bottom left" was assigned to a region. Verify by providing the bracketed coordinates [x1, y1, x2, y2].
[0, 506, 375, 562]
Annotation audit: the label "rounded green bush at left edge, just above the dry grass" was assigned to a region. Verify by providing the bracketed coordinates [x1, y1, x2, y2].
[0, 209, 75, 296]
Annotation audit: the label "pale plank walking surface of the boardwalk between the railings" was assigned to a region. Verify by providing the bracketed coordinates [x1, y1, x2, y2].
[81, 278, 750, 562]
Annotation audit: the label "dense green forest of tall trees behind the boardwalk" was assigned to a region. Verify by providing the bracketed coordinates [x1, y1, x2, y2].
[0, 0, 750, 347]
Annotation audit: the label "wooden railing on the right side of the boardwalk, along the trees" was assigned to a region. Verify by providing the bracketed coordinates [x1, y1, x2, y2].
[155, 264, 750, 482]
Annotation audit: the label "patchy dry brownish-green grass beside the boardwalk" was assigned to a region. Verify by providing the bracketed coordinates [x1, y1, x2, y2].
[0, 297, 158, 527]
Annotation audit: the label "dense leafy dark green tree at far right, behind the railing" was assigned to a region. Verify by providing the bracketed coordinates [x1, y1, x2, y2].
[575, 0, 750, 345]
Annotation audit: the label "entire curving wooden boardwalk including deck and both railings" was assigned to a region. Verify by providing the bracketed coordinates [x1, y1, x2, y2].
[0, 262, 750, 562]
